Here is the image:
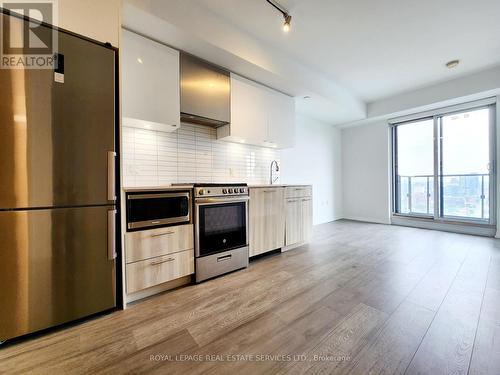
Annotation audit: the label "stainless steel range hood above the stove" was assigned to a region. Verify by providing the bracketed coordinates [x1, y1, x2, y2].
[180, 53, 231, 127]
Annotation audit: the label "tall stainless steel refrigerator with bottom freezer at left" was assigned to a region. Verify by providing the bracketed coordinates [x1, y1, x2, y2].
[0, 14, 118, 341]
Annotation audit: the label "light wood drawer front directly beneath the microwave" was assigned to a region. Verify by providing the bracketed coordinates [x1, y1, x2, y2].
[125, 224, 194, 263]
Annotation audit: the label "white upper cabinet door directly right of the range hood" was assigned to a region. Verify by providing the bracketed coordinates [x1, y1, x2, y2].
[230, 74, 267, 144]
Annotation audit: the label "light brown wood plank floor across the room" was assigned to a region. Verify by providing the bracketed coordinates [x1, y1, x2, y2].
[0, 220, 500, 374]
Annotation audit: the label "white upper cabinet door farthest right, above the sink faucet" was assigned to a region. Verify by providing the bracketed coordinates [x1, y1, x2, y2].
[267, 90, 295, 148]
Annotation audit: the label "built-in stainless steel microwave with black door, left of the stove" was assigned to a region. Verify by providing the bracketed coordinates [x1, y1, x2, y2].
[126, 191, 191, 231]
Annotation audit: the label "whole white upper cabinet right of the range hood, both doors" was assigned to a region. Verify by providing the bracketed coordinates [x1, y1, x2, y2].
[217, 74, 295, 148]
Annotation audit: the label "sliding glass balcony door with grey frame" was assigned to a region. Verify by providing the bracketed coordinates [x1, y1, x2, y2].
[392, 106, 495, 224]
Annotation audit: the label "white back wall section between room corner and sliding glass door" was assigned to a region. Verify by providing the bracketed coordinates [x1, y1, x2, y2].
[342, 121, 390, 224]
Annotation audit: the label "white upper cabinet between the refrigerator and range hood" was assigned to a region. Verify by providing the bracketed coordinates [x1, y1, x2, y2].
[122, 30, 180, 132]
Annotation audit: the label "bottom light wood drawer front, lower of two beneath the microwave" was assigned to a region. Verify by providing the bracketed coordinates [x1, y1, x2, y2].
[126, 250, 194, 293]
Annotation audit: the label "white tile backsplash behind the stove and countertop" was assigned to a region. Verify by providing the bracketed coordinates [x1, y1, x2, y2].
[122, 124, 280, 187]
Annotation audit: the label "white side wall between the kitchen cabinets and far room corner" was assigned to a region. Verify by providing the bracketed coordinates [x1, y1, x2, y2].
[281, 115, 342, 225]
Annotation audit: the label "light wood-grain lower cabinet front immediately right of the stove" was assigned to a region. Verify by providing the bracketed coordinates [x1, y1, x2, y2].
[249, 188, 285, 256]
